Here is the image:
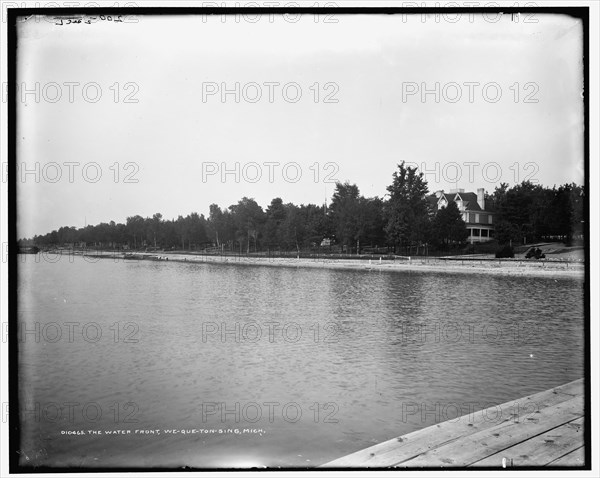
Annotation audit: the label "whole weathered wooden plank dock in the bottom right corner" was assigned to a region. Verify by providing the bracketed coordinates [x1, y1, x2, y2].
[321, 379, 585, 468]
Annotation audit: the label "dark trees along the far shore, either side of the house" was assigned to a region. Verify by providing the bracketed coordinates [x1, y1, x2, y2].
[19, 162, 586, 255]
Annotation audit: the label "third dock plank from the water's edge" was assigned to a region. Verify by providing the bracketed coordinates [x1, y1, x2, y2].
[470, 417, 584, 467]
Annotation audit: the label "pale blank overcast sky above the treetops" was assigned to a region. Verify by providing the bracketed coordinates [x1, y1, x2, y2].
[17, 14, 584, 237]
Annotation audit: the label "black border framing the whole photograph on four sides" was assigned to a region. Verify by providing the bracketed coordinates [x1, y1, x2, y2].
[7, 6, 595, 474]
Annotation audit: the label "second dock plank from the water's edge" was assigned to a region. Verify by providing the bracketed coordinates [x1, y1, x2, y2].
[395, 397, 583, 468]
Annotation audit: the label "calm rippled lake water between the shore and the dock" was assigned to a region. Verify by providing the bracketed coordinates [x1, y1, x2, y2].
[18, 255, 584, 467]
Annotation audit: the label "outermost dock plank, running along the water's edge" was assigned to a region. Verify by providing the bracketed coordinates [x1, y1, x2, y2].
[321, 379, 584, 468]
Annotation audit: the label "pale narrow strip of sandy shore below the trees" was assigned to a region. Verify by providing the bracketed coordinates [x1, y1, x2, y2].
[68, 251, 585, 279]
